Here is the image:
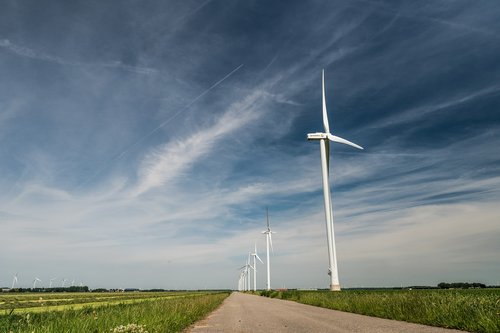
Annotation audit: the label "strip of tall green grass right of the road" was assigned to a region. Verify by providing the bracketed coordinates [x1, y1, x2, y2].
[263, 289, 500, 333]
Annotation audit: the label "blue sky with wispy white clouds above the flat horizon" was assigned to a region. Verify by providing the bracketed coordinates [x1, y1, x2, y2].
[0, 0, 500, 289]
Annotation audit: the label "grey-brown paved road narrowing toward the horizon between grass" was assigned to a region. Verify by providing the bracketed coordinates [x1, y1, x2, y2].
[187, 293, 463, 333]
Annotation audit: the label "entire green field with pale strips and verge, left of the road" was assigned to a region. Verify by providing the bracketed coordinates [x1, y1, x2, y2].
[0, 292, 229, 333]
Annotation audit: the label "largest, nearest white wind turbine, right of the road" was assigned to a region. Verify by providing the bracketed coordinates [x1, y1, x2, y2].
[307, 70, 363, 291]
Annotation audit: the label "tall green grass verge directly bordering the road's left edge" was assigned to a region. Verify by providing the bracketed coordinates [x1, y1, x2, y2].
[0, 293, 229, 333]
